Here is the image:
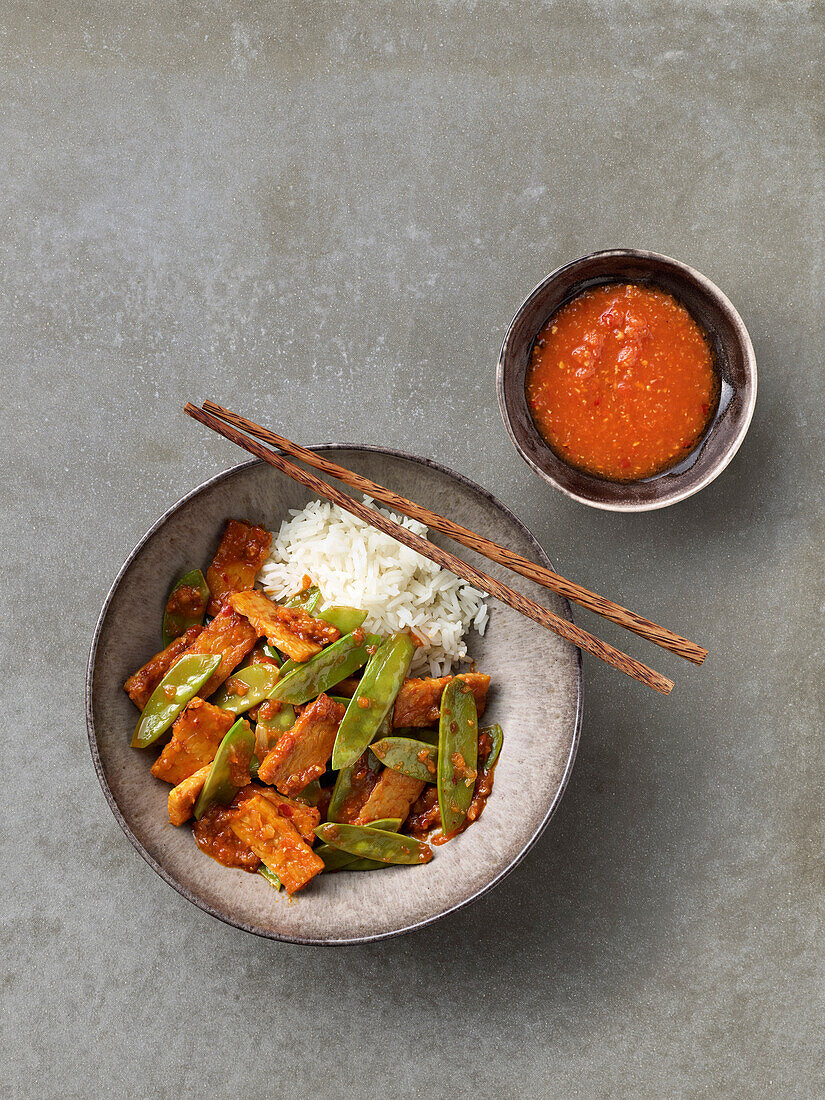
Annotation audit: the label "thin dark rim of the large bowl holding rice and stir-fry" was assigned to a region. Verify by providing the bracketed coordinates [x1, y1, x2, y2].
[86, 443, 584, 947]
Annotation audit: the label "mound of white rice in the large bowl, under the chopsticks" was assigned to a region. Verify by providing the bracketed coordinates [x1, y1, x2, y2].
[259, 496, 487, 677]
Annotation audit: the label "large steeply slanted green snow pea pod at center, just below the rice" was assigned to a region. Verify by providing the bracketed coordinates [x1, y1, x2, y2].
[332, 634, 415, 769]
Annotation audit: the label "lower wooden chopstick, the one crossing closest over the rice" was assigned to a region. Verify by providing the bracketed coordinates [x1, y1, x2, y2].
[184, 403, 673, 695]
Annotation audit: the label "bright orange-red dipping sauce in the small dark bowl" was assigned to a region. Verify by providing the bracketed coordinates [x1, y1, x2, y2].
[525, 283, 719, 481]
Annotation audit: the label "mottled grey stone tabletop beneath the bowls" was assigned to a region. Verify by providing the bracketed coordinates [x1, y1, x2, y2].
[0, 0, 825, 1098]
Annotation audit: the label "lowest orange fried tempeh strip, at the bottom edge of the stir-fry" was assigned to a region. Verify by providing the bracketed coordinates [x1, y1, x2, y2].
[229, 793, 323, 894]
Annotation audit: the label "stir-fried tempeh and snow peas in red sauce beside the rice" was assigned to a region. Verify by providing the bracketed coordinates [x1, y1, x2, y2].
[123, 519, 503, 894]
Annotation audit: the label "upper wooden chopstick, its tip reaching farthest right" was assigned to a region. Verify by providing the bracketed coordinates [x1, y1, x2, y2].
[204, 402, 707, 664]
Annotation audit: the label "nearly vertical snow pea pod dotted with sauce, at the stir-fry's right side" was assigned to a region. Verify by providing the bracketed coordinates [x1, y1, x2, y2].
[438, 680, 479, 836]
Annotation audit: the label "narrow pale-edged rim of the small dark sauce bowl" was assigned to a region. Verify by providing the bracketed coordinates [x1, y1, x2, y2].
[496, 249, 757, 512]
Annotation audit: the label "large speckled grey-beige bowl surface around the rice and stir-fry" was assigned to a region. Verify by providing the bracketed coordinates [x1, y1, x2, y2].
[87, 446, 582, 945]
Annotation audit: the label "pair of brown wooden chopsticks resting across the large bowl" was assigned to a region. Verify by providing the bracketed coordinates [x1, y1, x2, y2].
[184, 402, 707, 695]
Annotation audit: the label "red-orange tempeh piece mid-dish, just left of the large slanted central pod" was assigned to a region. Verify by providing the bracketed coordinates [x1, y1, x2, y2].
[257, 695, 344, 794]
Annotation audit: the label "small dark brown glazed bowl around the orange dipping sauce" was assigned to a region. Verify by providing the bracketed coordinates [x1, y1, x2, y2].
[496, 249, 757, 512]
